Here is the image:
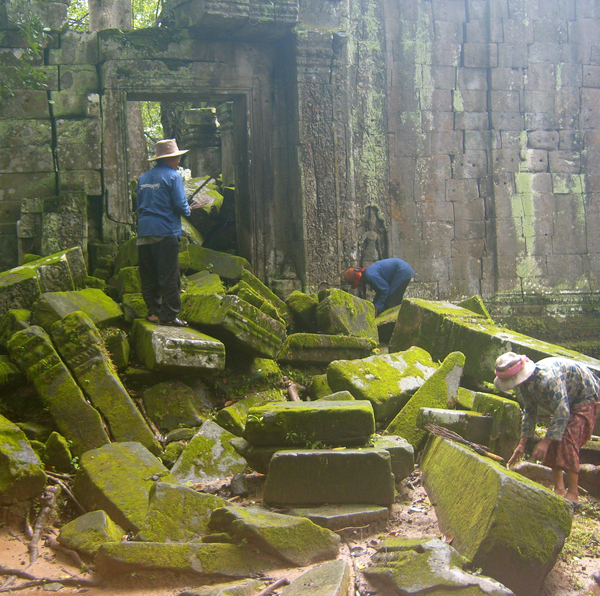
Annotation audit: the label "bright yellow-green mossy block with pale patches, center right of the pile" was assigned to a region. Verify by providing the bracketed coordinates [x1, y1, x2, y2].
[327, 347, 437, 424]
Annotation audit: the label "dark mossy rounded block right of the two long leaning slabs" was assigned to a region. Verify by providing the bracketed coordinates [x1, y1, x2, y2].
[143, 381, 209, 432]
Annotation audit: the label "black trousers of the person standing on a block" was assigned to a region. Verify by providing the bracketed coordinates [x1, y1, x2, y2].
[138, 236, 181, 323]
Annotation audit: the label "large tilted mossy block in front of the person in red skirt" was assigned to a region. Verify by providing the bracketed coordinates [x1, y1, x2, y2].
[421, 437, 572, 596]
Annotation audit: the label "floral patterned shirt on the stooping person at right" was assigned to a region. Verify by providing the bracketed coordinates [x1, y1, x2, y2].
[516, 358, 600, 441]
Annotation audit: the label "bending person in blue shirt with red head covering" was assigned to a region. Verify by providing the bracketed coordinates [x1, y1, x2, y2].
[344, 259, 415, 315]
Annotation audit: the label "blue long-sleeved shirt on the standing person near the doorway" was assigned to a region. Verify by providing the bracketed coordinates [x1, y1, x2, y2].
[137, 163, 190, 238]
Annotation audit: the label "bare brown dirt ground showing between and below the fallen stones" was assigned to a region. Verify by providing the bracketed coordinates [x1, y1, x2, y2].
[0, 474, 600, 596]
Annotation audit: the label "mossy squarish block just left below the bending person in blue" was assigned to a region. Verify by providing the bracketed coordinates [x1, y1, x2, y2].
[316, 290, 379, 342]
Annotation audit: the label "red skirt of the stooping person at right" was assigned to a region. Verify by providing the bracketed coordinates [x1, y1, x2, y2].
[543, 402, 600, 474]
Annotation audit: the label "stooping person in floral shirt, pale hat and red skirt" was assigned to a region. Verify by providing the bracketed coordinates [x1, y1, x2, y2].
[494, 352, 600, 503]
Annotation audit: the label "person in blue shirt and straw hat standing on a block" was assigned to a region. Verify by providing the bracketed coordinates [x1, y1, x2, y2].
[137, 139, 197, 327]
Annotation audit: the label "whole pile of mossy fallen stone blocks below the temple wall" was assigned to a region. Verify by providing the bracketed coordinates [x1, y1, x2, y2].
[0, 241, 600, 596]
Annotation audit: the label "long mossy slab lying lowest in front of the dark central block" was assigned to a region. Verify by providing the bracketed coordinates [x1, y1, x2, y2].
[209, 507, 340, 567]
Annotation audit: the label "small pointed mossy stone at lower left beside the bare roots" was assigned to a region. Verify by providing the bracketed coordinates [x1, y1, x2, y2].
[57, 511, 125, 556]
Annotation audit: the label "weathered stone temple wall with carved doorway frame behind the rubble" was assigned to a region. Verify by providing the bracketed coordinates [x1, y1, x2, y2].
[0, 0, 600, 312]
